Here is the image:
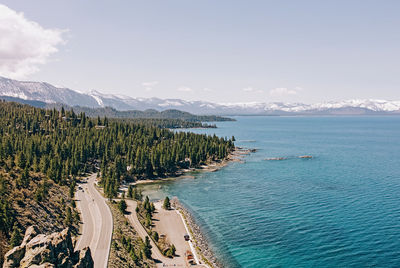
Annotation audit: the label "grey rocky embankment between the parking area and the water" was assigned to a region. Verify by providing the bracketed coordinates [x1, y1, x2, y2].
[171, 197, 224, 268]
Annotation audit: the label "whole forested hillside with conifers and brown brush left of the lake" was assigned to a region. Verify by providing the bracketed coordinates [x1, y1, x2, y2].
[0, 101, 234, 264]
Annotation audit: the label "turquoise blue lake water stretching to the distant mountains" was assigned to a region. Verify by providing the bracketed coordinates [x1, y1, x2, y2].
[140, 117, 400, 267]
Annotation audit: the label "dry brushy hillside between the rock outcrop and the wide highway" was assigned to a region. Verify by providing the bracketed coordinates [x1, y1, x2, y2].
[0, 161, 80, 265]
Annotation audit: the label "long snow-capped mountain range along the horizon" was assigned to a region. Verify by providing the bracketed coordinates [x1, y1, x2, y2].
[0, 77, 400, 115]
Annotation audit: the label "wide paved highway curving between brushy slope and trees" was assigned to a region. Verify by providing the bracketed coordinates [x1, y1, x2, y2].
[75, 174, 113, 268]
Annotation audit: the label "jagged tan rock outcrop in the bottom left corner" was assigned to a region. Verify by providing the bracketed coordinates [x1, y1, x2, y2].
[3, 226, 93, 268]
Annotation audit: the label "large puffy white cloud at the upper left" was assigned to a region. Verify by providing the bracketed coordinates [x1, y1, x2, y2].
[0, 4, 65, 78]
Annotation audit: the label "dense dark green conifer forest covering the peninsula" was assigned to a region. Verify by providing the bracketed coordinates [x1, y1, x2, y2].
[0, 102, 234, 241]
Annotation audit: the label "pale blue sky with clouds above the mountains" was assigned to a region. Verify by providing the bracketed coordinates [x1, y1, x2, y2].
[0, 0, 400, 103]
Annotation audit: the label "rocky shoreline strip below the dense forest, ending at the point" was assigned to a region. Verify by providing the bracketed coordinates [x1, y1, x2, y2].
[131, 147, 256, 185]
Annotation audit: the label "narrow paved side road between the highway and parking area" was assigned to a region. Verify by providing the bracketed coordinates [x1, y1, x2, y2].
[126, 200, 186, 267]
